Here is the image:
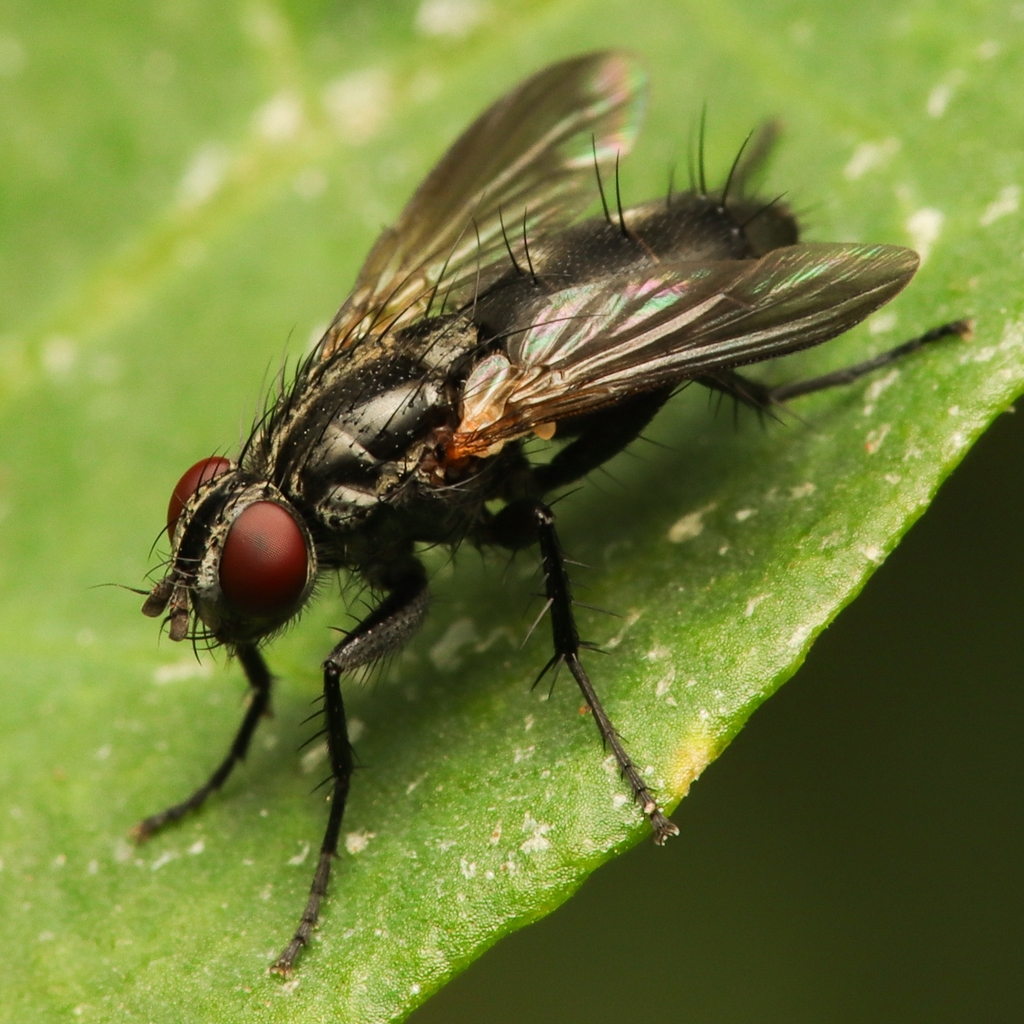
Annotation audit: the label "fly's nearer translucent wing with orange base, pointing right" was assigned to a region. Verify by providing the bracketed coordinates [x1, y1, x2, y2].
[447, 245, 920, 459]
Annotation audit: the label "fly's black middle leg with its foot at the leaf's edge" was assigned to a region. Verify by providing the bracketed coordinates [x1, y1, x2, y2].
[490, 500, 679, 846]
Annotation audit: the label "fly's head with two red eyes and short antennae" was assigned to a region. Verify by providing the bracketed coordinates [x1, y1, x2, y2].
[142, 457, 316, 644]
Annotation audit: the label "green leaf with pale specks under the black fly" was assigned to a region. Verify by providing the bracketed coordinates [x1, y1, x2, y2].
[0, 0, 1024, 1021]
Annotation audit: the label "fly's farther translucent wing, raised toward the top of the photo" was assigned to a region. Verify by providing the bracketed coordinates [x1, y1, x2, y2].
[313, 51, 644, 362]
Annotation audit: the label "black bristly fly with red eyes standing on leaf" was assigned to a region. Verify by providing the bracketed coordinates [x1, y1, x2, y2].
[135, 51, 968, 974]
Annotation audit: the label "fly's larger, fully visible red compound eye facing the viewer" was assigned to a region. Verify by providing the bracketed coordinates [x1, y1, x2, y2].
[220, 502, 309, 617]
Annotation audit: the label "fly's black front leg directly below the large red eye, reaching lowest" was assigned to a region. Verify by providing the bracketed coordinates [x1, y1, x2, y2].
[270, 563, 429, 975]
